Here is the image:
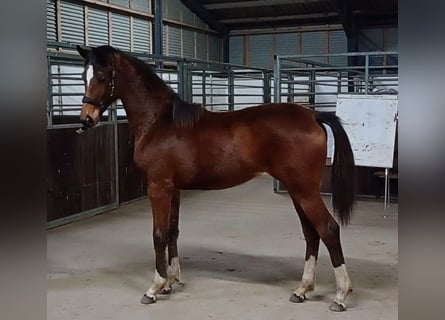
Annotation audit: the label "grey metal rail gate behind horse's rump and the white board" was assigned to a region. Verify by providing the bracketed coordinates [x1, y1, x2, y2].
[274, 51, 399, 196]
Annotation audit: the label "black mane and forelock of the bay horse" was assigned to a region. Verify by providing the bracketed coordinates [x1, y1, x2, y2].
[92, 46, 204, 128]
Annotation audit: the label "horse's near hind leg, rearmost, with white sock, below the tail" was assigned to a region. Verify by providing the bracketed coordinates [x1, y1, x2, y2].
[299, 193, 352, 311]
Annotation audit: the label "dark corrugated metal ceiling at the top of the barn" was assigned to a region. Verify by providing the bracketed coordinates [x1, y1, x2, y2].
[183, 0, 398, 31]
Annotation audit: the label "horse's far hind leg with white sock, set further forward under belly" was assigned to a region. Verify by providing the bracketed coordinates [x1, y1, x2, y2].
[289, 196, 320, 302]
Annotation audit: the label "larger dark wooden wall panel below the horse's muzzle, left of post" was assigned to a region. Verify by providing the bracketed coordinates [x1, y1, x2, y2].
[47, 125, 116, 221]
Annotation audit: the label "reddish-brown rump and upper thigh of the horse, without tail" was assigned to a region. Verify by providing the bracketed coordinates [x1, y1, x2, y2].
[250, 104, 327, 197]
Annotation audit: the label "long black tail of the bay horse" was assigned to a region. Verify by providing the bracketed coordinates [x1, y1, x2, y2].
[316, 112, 355, 225]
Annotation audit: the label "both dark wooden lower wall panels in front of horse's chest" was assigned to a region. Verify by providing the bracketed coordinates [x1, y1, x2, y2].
[47, 123, 147, 221]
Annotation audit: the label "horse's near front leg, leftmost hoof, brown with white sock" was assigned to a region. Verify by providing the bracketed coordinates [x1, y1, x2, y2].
[141, 181, 174, 304]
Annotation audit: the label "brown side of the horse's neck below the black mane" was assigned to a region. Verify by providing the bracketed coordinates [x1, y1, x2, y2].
[116, 57, 173, 137]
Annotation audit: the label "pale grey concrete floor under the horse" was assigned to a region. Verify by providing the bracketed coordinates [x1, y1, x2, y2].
[47, 176, 398, 320]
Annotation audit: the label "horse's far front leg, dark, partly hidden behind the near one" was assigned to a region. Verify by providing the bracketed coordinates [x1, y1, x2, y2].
[162, 189, 183, 294]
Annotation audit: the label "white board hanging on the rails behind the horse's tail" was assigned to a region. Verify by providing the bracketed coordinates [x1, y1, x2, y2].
[336, 94, 398, 168]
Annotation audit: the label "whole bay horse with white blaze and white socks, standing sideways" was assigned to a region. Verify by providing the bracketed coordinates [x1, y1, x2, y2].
[77, 46, 354, 311]
